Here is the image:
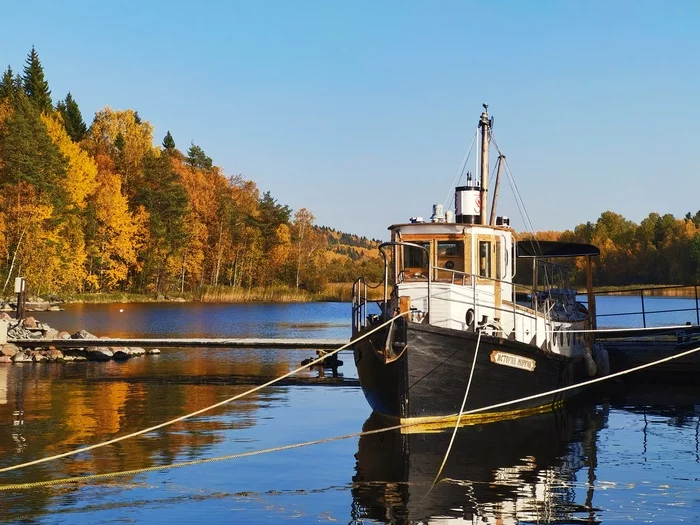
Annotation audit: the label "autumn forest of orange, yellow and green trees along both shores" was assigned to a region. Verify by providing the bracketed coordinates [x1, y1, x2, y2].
[0, 48, 700, 296]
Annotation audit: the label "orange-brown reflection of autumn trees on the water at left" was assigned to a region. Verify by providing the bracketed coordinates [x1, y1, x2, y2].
[0, 349, 300, 522]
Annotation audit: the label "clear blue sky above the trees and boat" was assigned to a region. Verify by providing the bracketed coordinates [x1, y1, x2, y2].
[0, 0, 700, 239]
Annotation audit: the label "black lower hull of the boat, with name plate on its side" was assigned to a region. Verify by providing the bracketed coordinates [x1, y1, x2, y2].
[354, 322, 582, 423]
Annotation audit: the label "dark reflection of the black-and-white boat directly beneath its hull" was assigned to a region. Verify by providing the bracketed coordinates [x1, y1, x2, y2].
[352, 402, 607, 524]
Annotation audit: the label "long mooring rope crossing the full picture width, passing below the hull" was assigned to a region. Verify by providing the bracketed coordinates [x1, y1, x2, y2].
[0, 340, 700, 491]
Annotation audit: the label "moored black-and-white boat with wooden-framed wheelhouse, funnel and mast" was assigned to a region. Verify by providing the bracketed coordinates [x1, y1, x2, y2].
[352, 105, 604, 429]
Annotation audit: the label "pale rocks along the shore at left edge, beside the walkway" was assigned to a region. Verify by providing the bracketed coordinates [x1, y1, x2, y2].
[0, 312, 160, 363]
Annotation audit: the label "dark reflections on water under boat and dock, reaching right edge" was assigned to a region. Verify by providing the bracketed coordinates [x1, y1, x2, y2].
[352, 383, 700, 523]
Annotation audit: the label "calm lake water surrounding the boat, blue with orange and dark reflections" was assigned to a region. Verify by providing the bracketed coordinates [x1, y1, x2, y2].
[0, 297, 700, 524]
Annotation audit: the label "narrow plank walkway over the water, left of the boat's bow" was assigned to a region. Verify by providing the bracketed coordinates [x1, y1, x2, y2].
[7, 337, 348, 350]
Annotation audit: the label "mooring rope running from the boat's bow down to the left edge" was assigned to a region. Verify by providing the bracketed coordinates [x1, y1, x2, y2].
[0, 311, 410, 473]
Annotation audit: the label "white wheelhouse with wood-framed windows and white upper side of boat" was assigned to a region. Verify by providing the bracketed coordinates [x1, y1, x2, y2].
[387, 217, 585, 355]
